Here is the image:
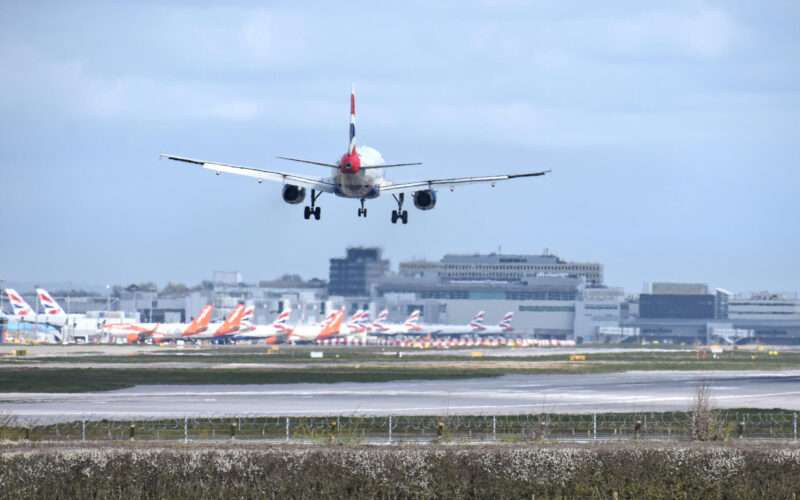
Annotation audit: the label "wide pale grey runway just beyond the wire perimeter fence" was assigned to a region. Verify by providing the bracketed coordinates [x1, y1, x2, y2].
[6, 370, 800, 422]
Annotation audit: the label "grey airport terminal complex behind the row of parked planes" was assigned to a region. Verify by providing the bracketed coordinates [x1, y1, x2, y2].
[7, 247, 800, 344]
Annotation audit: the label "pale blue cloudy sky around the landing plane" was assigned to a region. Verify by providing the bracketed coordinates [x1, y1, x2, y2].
[0, 0, 800, 292]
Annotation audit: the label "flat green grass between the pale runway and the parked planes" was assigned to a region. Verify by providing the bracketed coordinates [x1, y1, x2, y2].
[0, 348, 800, 392]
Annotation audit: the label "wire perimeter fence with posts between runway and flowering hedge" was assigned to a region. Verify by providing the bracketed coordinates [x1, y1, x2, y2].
[0, 410, 798, 444]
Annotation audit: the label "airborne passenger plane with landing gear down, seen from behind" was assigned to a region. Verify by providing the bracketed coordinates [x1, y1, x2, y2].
[161, 86, 549, 224]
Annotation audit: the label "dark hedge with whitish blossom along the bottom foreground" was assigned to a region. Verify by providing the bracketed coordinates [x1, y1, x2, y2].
[0, 443, 800, 498]
